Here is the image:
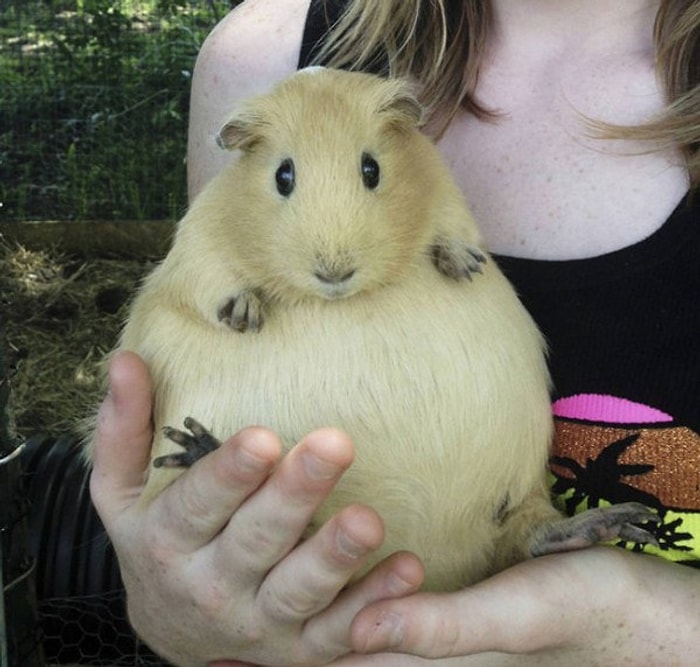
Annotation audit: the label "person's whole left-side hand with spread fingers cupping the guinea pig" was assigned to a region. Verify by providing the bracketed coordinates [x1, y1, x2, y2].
[90, 353, 423, 667]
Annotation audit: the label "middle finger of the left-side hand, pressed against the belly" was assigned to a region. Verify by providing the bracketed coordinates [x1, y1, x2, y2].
[222, 429, 354, 581]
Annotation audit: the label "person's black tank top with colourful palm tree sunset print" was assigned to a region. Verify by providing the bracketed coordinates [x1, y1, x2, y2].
[299, 0, 700, 565]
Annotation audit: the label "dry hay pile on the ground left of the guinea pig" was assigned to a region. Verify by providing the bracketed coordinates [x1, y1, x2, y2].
[0, 243, 150, 436]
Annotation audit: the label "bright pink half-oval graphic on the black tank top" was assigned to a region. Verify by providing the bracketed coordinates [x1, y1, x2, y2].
[552, 394, 673, 424]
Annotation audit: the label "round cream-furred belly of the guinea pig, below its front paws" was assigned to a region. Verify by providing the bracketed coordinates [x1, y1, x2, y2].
[145, 268, 551, 588]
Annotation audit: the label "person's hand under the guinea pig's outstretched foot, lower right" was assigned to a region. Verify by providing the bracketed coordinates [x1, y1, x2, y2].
[337, 547, 700, 667]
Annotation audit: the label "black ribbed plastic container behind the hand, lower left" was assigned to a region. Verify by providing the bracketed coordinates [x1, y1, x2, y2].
[22, 435, 166, 665]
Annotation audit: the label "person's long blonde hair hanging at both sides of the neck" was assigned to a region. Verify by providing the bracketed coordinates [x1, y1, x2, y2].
[318, 0, 700, 186]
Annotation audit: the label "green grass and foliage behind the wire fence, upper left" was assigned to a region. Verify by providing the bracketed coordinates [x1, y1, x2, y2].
[0, 0, 237, 221]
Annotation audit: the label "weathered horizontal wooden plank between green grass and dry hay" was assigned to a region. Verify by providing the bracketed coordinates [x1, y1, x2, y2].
[0, 220, 175, 259]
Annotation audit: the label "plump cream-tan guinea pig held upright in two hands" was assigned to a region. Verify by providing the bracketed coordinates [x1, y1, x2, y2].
[86, 68, 653, 590]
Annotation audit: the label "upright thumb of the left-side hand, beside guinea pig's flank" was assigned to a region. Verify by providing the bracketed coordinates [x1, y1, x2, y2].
[90, 352, 153, 527]
